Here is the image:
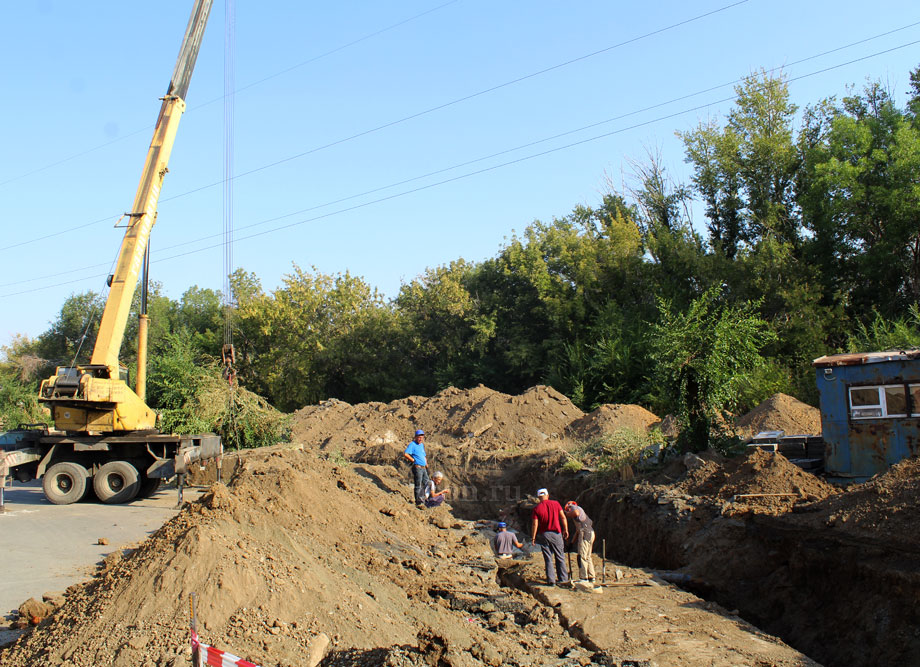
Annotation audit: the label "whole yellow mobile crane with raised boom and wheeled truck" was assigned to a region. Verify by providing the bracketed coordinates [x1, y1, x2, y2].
[0, 0, 222, 505]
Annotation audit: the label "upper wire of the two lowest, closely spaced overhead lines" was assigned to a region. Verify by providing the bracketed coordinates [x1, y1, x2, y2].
[0, 32, 920, 289]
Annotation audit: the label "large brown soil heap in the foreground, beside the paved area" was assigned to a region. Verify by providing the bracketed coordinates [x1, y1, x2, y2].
[0, 450, 578, 667]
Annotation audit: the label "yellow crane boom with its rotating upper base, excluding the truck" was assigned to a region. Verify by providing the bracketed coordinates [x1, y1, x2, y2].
[39, 0, 212, 432]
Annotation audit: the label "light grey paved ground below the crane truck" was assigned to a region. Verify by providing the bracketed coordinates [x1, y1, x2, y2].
[0, 482, 201, 618]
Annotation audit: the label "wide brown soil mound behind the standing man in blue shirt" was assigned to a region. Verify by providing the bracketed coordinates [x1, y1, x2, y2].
[292, 385, 584, 518]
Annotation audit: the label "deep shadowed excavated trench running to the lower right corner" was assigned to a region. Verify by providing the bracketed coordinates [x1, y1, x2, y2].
[448, 462, 920, 667]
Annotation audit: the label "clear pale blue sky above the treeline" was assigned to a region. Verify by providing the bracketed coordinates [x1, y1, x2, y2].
[0, 0, 920, 345]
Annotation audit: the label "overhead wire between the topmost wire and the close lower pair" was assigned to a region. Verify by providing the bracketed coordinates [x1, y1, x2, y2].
[0, 0, 751, 252]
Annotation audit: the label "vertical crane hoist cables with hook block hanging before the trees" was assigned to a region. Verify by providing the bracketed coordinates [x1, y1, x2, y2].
[221, 0, 238, 444]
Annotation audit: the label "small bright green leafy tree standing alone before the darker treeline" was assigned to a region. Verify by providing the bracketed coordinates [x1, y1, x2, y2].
[650, 287, 775, 451]
